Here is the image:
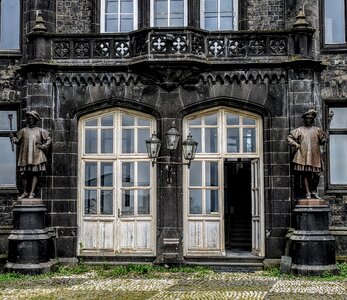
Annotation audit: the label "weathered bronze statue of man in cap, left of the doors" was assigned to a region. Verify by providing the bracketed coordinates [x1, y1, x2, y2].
[10, 110, 52, 199]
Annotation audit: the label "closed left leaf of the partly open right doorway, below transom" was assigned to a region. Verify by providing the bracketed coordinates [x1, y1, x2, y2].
[185, 160, 224, 256]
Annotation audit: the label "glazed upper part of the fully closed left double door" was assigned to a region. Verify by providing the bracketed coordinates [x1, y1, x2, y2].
[81, 110, 154, 216]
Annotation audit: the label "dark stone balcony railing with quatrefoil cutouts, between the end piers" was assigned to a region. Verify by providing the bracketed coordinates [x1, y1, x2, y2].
[49, 29, 295, 62]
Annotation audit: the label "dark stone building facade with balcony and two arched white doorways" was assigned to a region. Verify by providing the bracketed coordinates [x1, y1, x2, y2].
[0, 0, 347, 266]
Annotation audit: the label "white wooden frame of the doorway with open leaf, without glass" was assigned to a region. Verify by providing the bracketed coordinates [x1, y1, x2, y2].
[183, 107, 265, 257]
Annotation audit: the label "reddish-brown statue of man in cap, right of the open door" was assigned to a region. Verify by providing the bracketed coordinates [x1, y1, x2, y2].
[287, 109, 329, 199]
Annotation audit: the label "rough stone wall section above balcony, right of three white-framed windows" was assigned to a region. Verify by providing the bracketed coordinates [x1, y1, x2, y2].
[246, 0, 284, 30]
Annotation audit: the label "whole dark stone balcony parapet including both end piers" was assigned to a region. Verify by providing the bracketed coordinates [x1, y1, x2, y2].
[28, 24, 320, 66]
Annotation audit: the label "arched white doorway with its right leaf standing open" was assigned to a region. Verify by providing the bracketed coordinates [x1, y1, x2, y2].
[183, 107, 265, 256]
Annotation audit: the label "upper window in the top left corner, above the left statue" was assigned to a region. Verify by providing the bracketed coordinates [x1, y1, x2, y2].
[0, 0, 20, 50]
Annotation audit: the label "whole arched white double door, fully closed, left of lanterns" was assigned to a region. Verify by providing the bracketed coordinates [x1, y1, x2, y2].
[79, 109, 155, 254]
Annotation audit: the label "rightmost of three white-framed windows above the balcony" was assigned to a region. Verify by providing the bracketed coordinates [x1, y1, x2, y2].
[201, 0, 238, 31]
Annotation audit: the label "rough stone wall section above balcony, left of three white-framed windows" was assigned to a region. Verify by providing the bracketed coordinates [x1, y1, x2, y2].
[56, 0, 92, 33]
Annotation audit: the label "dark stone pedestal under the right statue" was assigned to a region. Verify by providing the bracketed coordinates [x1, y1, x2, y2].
[290, 199, 338, 276]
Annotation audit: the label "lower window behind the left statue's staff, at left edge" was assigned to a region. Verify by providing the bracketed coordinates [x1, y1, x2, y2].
[0, 110, 17, 187]
